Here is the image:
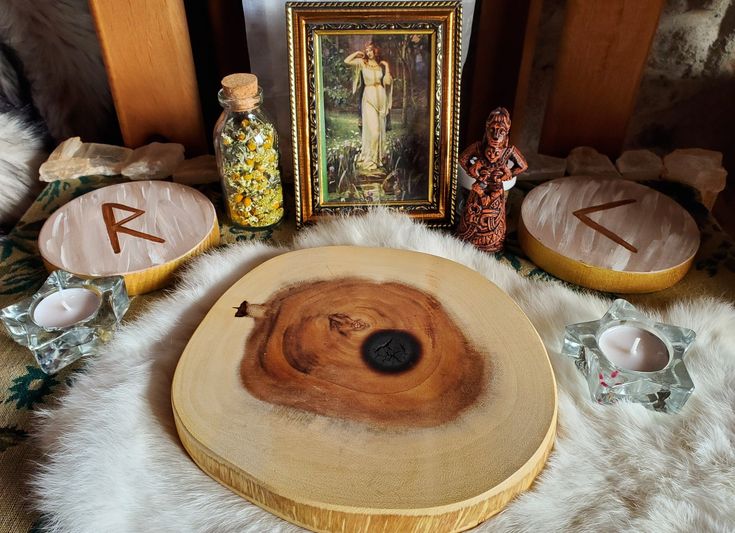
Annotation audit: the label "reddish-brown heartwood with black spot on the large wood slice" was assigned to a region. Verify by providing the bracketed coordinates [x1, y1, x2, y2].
[239, 278, 486, 427]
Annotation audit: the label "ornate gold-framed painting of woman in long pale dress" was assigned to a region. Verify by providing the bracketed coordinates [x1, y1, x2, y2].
[286, 0, 461, 226]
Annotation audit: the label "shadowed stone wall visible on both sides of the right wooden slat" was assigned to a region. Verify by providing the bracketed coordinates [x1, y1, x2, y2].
[519, 0, 735, 173]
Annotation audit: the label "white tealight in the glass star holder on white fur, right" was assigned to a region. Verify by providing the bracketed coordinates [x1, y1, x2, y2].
[597, 325, 669, 372]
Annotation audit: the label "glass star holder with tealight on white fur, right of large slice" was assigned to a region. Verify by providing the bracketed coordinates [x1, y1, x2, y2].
[562, 300, 696, 412]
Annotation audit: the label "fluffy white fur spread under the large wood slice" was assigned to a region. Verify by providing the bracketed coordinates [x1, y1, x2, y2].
[33, 211, 735, 533]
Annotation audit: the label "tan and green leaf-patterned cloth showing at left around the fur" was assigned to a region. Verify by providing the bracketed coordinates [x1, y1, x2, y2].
[0, 176, 295, 533]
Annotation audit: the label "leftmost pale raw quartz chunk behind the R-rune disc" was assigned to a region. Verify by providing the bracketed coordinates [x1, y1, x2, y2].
[39, 137, 133, 181]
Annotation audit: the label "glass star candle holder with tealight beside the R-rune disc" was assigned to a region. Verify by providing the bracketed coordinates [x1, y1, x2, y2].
[0, 270, 130, 374]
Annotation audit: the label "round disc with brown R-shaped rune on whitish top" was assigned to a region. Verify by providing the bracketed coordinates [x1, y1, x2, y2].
[38, 181, 219, 294]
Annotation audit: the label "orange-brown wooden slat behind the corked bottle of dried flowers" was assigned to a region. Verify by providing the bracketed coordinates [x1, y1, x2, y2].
[89, 0, 207, 156]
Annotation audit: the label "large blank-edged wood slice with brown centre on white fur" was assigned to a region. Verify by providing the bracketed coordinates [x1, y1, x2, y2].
[172, 247, 557, 532]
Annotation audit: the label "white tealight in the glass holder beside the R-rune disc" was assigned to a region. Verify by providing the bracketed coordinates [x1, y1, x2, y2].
[33, 287, 101, 328]
